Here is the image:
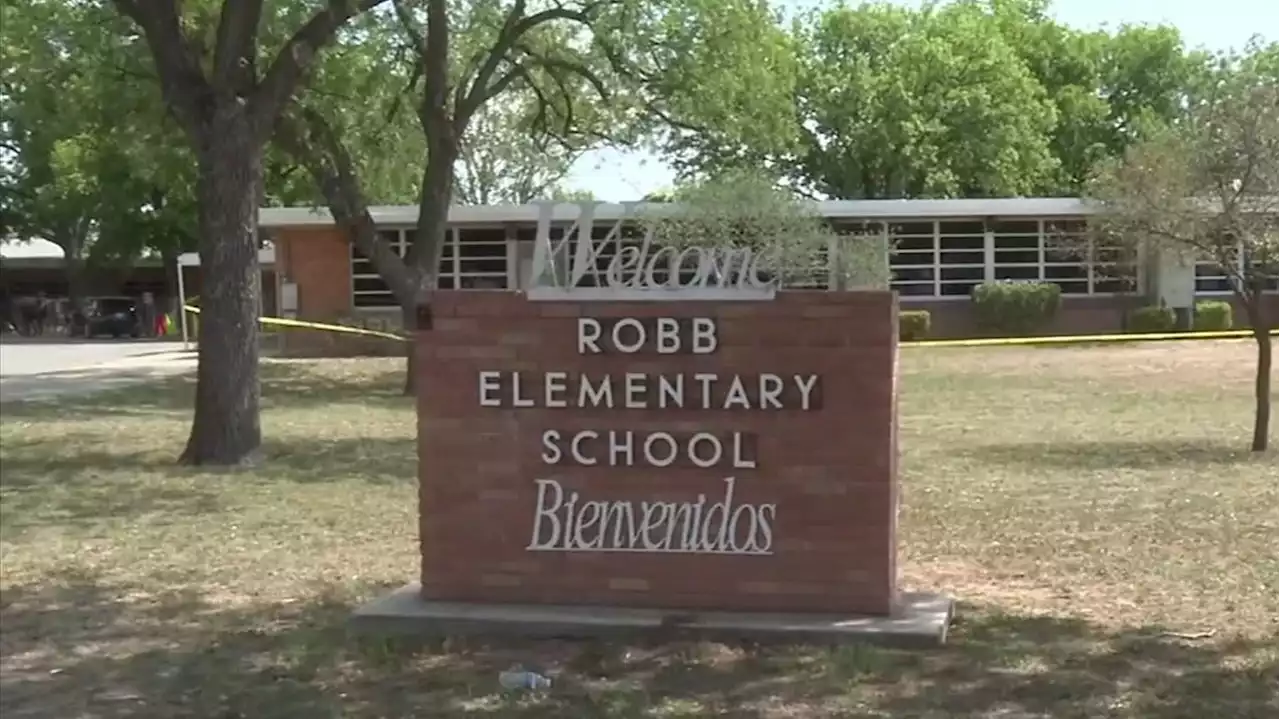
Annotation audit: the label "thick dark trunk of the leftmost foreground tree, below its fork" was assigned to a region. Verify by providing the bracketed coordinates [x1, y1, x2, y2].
[182, 109, 262, 466]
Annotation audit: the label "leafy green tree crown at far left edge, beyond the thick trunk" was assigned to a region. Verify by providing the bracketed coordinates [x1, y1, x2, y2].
[0, 0, 179, 303]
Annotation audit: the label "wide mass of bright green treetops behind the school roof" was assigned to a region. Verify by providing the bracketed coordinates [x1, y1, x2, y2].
[648, 0, 1239, 198]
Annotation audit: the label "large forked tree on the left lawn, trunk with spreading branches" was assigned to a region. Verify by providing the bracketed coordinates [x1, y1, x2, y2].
[113, 0, 380, 466]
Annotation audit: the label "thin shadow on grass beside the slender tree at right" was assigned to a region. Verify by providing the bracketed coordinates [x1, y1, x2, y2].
[964, 440, 1261, 470]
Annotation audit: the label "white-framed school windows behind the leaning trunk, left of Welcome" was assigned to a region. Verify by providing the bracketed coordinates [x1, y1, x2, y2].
[351, 228, 508, 307]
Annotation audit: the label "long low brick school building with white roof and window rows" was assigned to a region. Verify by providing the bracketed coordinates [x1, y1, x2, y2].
[260, 197, 1280, 354]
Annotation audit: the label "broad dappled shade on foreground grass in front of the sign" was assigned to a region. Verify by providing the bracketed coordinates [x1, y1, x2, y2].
[0, 571, 1280, 719]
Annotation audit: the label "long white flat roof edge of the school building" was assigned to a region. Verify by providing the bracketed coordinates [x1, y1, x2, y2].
[257, 197, 1096, 228]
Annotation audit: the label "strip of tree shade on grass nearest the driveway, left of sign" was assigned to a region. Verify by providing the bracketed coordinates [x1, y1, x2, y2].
[4, 362, 412, 421]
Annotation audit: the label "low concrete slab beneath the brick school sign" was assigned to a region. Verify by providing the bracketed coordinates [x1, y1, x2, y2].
[351, 582, 952, 649]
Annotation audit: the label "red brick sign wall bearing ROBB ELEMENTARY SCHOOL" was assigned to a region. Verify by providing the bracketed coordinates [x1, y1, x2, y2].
[417, 290, 899, 613]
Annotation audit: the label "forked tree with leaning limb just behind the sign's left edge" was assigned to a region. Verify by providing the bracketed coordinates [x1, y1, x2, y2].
[276, 0, 640, 393]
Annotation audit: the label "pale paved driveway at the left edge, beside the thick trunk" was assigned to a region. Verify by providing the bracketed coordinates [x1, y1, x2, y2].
[0, 342, 196, 402]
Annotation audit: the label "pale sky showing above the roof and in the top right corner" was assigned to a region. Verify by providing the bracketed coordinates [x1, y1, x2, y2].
[566, 0, 1280, 202]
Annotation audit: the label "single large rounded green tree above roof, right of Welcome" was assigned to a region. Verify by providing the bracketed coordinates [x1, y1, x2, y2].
[795, 4, 1057, 198]
